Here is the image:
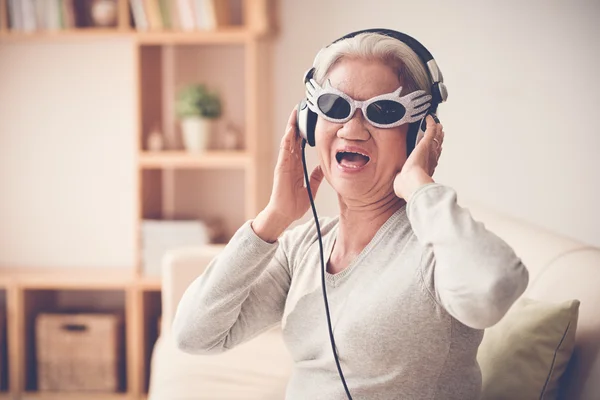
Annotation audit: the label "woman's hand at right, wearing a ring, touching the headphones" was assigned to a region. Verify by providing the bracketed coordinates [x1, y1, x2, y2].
[394, 115, 444, 202]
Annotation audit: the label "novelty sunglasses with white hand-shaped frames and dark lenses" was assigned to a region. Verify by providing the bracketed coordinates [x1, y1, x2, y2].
[306, 79, 431, 128]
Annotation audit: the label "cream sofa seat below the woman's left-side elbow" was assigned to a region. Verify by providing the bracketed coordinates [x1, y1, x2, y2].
[148, 327, 292, 400]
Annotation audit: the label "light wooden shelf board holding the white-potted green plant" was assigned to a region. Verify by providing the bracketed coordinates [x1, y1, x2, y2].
[139, 151, 250, 169]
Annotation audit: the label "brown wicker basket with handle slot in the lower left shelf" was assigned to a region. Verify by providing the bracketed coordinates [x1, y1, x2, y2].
[36, 314, 124, 392]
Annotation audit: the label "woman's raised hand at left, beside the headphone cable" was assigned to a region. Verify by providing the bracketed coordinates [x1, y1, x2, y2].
[252, 108, 323, 243]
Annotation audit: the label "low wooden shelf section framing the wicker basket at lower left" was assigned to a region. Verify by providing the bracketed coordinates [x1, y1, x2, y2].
[0, 268, 190, 400]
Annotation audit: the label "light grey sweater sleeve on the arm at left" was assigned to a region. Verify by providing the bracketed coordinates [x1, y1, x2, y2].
[173, 221, 291, 354]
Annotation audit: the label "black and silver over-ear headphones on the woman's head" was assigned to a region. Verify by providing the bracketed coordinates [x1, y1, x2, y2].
[297, 29, 448, 156]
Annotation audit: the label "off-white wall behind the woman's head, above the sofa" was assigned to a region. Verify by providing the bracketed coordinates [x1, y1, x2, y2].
[274, 0, 600, 246]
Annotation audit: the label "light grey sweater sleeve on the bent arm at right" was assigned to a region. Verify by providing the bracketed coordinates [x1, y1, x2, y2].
[407, 183, 529, 329]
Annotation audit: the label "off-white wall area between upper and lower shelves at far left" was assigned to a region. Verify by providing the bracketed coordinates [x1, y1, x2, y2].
[0, 40, 137, 268]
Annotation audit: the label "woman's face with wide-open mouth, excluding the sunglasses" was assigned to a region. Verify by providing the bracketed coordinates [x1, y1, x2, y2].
[315, 58, 408, 204]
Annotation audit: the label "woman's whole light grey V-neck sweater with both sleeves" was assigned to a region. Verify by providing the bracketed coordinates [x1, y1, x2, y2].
[173, 183, 529, 400]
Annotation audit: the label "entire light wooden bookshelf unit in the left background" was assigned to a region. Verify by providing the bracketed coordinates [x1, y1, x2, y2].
[0, 0, 273, 400]
